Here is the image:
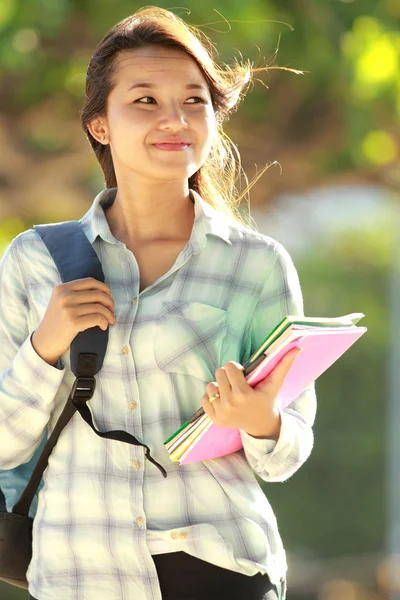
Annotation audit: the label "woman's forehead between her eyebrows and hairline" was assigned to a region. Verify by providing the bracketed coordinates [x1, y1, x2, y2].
[113, 46, 207, 85]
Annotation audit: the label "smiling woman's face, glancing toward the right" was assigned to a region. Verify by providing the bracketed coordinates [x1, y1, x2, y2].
[98, 46, 215, 181]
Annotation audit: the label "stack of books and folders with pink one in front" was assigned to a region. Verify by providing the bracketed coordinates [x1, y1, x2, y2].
[164, 313, 367, 464]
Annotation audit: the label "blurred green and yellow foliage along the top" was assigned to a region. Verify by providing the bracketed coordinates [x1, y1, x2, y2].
[0, 0, 400, 171]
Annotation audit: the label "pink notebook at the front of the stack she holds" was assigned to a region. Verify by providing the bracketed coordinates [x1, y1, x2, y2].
[179, 327, 367, 464]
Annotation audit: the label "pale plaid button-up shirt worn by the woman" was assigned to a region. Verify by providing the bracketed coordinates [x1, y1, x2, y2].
[0, 188, 316, 600]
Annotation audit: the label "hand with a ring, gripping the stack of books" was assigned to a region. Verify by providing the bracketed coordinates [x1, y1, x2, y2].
[201, 348, 302, 440]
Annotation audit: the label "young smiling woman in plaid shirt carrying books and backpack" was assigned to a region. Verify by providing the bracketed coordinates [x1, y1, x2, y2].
[0, 7, 316, 600]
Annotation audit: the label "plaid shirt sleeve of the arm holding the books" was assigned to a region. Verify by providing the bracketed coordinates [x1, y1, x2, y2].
[240, 244, 317, 481]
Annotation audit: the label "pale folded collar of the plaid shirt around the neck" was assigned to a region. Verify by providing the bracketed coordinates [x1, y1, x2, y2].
[80, 187, 231, 253]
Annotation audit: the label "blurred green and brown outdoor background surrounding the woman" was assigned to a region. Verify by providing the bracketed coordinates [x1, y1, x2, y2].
[0, 0, 400, 600]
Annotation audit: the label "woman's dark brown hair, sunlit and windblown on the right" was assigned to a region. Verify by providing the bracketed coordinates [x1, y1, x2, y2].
[80, 6, 288, 222]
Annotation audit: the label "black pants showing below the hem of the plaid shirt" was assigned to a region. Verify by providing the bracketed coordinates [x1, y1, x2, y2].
[30, 552, 281, 600]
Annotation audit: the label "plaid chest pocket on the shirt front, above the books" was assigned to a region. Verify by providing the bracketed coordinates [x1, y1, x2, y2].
[154, 302, 227, 383]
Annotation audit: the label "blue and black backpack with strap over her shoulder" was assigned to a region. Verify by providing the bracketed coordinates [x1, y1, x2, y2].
[0, 221, 167, 589]
